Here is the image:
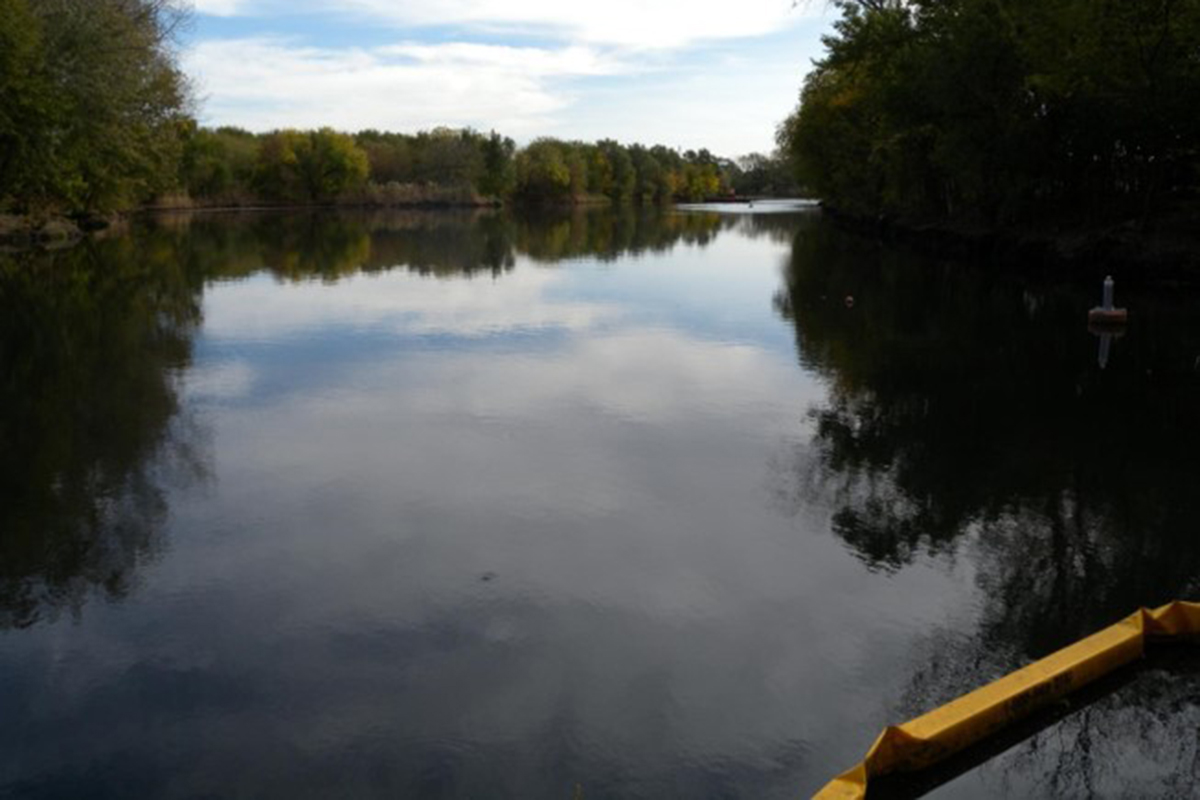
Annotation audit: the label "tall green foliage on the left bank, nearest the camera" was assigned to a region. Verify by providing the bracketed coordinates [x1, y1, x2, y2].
[0, 0, 187, 211]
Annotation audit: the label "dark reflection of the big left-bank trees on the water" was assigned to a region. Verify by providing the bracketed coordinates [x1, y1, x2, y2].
[0, 239, 202, 628]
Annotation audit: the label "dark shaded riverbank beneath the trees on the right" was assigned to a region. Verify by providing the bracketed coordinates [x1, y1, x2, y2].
[821, 203, 1200, 283]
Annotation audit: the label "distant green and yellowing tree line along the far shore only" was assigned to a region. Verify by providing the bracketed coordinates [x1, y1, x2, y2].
[178, 126, 791, 205]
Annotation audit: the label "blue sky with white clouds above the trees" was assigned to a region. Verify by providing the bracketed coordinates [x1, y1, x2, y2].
[184, 0, 832, 156]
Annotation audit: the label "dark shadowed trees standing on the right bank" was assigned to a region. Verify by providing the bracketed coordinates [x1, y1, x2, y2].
[779, 0, 1200, 225]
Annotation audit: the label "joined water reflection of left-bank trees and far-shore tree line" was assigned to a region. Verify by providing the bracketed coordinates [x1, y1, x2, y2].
[0, 207, 733, 628]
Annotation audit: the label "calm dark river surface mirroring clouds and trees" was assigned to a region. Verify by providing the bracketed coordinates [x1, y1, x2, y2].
[0, 207, 1200, 800]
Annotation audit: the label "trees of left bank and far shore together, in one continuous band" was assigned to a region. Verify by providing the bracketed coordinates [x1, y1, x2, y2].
[0, 0, 791, 212]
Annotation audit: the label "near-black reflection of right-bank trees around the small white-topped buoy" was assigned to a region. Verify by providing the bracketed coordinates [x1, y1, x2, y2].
[775, 215, 1200, 796]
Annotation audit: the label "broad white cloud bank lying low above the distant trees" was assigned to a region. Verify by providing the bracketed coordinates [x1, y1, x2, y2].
[185, 38, 625, 136]
